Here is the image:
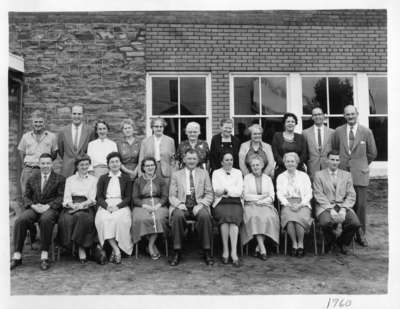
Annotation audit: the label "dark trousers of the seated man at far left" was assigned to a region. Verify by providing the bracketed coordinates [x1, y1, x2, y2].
[14, 208, 58, 252]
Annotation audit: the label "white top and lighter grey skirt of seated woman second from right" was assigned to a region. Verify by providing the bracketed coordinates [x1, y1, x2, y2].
[276, 170, 312, 232]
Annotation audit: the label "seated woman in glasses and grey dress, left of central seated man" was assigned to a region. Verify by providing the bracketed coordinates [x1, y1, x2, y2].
[132, 157, 168, 260]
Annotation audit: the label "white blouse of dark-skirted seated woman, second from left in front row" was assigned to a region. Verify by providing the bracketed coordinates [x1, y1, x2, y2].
[63, 172, 97, 207]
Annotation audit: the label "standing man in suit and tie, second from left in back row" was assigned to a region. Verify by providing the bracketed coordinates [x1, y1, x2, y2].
[58, 105, 93, 177]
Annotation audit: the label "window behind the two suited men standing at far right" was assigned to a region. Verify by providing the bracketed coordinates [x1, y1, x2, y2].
[301, 76, 354, 129]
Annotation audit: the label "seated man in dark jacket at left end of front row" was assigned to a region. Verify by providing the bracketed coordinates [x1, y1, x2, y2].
[11, 153, 65, 270]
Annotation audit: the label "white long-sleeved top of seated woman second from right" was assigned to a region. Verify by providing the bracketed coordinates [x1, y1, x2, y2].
[276, 170, 312, 208]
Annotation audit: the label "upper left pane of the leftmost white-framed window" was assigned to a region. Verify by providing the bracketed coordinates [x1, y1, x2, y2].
[152, 77, 178, 115]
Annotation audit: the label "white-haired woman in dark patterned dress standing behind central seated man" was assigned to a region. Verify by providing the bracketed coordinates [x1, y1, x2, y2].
[176, 121, 210, 171]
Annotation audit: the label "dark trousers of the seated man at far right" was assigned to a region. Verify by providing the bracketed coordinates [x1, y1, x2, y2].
[318, 209, 360, 246]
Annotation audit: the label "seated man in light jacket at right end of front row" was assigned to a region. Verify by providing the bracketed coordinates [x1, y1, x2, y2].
[314, 150, 360, 254]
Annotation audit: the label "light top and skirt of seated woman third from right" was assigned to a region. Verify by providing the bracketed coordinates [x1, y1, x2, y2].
[240, 174, 279, 244]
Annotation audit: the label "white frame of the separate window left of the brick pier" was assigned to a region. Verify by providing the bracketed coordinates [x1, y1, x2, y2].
[146, 72, 212, 144]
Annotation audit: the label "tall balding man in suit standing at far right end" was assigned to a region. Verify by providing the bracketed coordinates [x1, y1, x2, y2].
[332, 105, 377, 247]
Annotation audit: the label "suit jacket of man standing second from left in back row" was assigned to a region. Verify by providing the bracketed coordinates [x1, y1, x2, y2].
[58, 124, 94, 177]
